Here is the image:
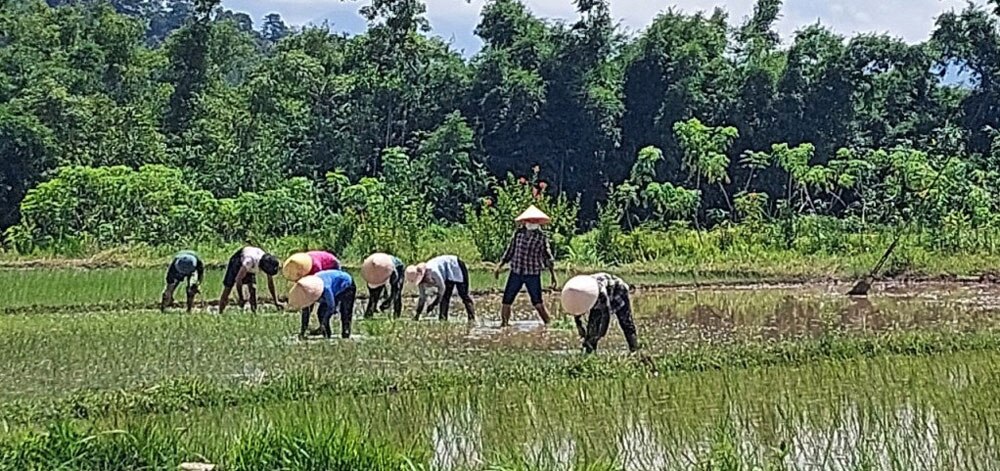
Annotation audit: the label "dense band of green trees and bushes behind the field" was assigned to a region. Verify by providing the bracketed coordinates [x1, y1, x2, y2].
[0, 0, 1000, 261]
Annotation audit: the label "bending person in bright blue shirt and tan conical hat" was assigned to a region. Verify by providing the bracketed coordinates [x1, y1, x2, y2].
[288, 270, 358, 339]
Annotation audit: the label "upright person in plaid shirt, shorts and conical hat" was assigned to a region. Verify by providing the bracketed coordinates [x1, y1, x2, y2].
[493, 206, 558, 327]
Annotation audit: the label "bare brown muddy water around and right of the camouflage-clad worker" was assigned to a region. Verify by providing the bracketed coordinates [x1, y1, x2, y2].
[462, 283, 1000, 352]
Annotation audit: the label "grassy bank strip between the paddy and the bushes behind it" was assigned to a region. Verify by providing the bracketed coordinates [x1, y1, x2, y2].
[0, 222, 1000, 279]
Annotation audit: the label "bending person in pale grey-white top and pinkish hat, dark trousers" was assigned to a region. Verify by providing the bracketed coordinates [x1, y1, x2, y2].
[406, 255, 476, 321]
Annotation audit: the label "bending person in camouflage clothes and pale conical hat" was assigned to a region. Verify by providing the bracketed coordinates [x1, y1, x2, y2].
[562, 273, 639, 353]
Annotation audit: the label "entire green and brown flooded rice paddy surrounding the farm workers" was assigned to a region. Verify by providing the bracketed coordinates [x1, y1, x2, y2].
[0, 269, 1000, 470]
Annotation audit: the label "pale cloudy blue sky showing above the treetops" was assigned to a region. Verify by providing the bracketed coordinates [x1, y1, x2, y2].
[222, 0, 985, 55]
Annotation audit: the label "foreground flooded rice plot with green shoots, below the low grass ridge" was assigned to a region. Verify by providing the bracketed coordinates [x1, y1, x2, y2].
[112, 353, 1000, 470]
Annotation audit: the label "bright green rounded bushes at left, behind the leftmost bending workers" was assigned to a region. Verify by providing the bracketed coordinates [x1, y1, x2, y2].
[7, 165, 323, 253]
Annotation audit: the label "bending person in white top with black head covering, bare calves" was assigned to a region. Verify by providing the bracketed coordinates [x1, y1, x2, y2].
[219, 247, 281, 314]
